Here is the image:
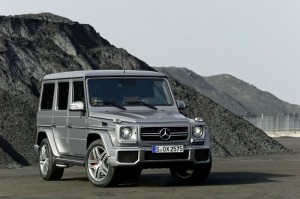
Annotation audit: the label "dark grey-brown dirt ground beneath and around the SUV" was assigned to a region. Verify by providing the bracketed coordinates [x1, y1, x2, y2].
[0, 138, 300, 199]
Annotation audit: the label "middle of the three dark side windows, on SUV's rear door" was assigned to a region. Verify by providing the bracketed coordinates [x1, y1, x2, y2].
[57, 82, 69, 110]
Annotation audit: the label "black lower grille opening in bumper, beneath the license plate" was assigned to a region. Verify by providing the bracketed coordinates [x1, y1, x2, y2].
[145, 151, 189, 160]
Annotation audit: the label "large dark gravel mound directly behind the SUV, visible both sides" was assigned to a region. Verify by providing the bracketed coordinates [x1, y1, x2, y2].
[0, 13, 288, 167]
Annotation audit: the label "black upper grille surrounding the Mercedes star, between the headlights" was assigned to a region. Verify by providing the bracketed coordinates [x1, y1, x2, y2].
[141, 127, 188, 141]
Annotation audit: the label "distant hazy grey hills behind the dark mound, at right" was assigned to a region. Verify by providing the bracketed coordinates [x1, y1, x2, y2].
[155, 67, 300, 115]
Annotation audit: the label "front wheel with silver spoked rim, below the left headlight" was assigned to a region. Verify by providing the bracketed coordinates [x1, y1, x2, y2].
[85, 140, 116, 187]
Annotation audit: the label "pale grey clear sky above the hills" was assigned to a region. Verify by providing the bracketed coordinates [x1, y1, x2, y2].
[0, 0, 300, 105]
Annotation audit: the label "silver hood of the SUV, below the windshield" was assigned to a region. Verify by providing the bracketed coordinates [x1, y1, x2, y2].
[89, 111, 189, 123]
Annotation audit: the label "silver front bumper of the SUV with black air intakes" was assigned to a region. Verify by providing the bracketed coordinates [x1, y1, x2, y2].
[108, 146, 211, 168]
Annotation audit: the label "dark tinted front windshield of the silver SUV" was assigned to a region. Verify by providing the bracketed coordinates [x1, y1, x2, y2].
[88, 78, 173, 110]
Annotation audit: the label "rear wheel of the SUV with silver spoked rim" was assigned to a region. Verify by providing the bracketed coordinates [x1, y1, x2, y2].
[39, 138, 64, 181]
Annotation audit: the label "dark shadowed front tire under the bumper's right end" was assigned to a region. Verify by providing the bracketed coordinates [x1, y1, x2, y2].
[170, 156, 212, 185]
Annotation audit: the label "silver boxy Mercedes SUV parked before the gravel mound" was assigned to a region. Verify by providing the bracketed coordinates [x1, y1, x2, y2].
[34, 70, 212, 187]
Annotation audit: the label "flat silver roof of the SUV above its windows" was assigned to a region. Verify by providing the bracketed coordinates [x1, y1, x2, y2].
[43, 70, 167, 80]
